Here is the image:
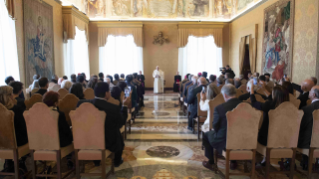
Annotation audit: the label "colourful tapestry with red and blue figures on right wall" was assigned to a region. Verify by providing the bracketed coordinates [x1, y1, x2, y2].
[262, 0, 294, 81]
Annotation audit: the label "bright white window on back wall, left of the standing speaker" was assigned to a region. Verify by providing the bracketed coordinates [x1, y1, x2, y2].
[99, 35, 143, 75]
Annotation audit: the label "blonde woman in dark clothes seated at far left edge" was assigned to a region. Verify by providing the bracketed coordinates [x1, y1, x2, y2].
[0, 86, 28, 172]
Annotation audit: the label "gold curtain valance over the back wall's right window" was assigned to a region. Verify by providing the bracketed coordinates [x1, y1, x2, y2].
[178, 22, 224, 48]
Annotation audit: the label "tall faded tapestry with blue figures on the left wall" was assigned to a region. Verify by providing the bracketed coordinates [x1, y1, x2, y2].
[24, 0, 54, 85]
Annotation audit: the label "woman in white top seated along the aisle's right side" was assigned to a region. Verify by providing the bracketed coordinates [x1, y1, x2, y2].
[199, 83, 220, 132]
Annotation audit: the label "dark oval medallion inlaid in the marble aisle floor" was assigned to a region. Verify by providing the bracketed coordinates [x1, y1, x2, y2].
[146, 146, 180, 158]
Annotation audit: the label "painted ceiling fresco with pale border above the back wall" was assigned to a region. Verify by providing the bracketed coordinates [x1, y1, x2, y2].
[62, 0, 262, 21]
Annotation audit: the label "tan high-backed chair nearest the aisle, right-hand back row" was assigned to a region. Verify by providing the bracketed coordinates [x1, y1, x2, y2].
[215, 103, 262, 179]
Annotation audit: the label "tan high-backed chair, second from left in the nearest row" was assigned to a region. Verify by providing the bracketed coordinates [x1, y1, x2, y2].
[23, 103, 74, 179]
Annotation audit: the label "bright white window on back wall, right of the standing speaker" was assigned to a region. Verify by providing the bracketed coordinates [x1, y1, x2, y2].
[178, 36, 223, 76]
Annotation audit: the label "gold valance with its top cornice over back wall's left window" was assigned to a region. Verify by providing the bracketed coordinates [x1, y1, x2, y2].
[97, 22, 143, 47]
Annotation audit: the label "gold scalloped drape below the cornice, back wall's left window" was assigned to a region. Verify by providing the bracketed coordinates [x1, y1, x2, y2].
[98, 27, 143, 47]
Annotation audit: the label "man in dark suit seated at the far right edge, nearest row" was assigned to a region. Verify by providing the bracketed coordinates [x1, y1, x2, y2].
[298, 86, 319, 170]
